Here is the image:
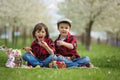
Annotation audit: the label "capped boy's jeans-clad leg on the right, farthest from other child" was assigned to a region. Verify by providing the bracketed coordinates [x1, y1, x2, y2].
[73, 56, 90, 67]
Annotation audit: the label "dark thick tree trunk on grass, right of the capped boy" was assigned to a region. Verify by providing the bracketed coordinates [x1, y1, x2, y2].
[85, 20, 94, 50]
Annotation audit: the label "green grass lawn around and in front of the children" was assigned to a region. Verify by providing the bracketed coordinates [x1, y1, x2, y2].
[0, 40, 120, 80]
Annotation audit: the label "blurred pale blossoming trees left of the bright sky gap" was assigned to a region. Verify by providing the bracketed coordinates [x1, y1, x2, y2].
[0, 0, 52, 48]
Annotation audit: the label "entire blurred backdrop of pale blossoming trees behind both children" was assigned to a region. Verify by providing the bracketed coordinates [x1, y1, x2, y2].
[0, 0, 120, 50]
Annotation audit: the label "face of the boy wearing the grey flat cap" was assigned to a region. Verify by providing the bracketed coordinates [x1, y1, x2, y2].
[58, 23, 70, 37]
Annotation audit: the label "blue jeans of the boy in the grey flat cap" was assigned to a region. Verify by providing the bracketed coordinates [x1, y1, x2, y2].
[57, 56, 90, 67]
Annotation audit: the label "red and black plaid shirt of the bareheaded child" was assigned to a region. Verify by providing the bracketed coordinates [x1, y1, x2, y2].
[31, 38, 55, 60]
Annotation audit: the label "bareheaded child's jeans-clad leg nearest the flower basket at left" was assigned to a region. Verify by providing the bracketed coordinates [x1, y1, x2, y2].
[23, 53, 43, 67]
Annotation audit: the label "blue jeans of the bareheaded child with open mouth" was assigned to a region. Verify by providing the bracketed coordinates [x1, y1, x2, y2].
[23, 53, 57, 67]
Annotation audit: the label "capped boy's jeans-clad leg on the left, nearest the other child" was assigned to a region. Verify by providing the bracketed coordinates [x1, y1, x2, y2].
[57, 56, 78, 67]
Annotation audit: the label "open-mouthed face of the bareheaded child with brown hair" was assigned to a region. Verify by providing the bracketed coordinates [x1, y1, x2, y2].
[35, 28, 46, 41]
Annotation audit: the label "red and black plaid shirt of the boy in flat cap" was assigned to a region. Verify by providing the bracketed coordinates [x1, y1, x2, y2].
[55, 33, 80, 58]
